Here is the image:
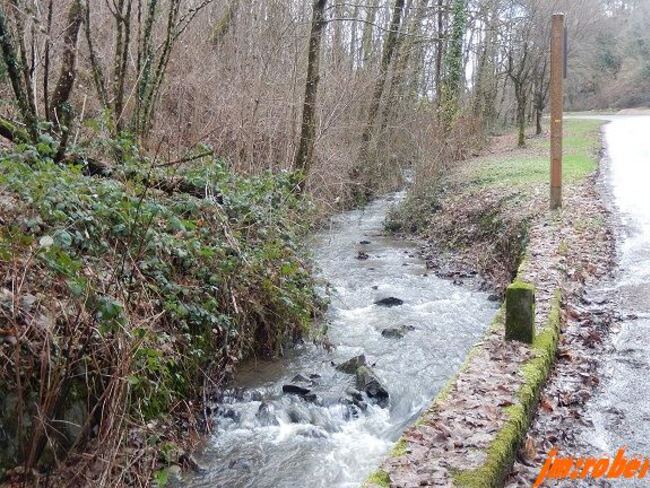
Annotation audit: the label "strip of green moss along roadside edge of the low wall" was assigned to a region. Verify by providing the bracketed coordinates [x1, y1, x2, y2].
[454, 289, 561, 488]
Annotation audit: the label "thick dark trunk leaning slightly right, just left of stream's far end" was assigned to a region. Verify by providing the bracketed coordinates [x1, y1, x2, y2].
[293, 0, 327, 191]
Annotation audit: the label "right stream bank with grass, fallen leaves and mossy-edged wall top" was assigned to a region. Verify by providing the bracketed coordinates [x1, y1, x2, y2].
[366, 121, 613, 488]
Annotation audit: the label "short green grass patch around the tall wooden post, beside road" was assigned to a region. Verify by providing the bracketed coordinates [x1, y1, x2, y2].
[469, 119, 604, 187]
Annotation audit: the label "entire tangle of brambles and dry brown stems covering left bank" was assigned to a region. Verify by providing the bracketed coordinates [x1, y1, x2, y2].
[0, 147, 319, 479]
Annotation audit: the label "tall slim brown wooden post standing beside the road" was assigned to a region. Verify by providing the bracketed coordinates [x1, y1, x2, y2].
[550, 14, 564, 210]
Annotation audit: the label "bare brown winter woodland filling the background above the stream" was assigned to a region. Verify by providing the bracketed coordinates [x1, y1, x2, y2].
[0, 0, 650, 201]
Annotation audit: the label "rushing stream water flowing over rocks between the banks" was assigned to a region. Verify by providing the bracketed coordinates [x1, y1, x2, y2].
[185, 189, 496, 488]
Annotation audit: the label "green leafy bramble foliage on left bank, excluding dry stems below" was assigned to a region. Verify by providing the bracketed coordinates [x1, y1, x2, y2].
[0, 149, 320, 424]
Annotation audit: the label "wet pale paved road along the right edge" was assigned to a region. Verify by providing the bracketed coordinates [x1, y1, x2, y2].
[584, 116, 650, 480]
